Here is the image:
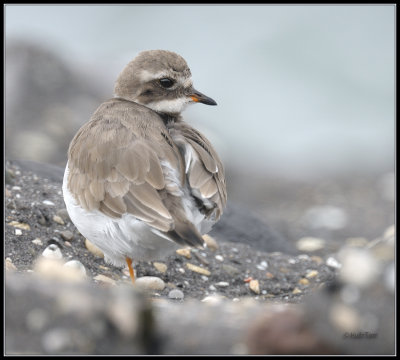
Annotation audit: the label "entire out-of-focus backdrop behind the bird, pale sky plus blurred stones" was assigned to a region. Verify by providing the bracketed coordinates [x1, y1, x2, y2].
[5, 5, 395, 249]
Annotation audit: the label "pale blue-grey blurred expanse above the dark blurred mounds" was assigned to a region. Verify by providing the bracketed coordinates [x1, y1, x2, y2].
[5, 5, 395, 178]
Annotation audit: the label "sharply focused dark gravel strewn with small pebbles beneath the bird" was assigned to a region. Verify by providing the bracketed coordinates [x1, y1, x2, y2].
[4, 162, 334, 303]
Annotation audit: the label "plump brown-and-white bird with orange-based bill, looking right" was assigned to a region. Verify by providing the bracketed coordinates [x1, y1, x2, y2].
[62, 50, 227, 283]
